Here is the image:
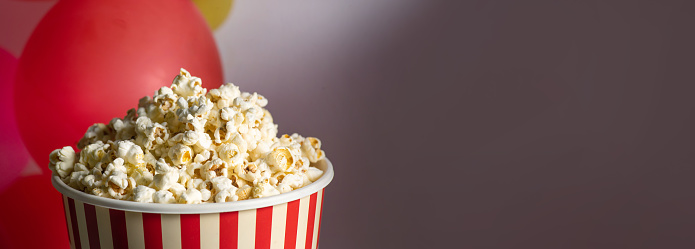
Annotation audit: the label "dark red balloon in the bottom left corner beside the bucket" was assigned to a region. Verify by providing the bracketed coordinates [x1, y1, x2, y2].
[0, 175, 70, 249]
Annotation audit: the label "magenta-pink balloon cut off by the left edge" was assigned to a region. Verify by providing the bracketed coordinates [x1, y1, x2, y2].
[0, 48, 29, 191]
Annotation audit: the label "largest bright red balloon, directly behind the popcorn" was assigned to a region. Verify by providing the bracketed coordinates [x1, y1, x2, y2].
[14, 0, 222, 175]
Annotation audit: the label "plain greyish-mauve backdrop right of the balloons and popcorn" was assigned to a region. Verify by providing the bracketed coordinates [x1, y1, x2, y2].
[216, 0, 695, 248]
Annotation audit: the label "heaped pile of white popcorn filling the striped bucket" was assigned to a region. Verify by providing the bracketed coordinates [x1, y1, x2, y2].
[49, 69, 325, 204]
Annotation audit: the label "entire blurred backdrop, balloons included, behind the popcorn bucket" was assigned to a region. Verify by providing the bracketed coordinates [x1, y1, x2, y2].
[0, 0, 695, 248]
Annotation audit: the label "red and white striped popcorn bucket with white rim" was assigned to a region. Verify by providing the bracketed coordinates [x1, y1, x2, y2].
[52, 159, 333, 249]
